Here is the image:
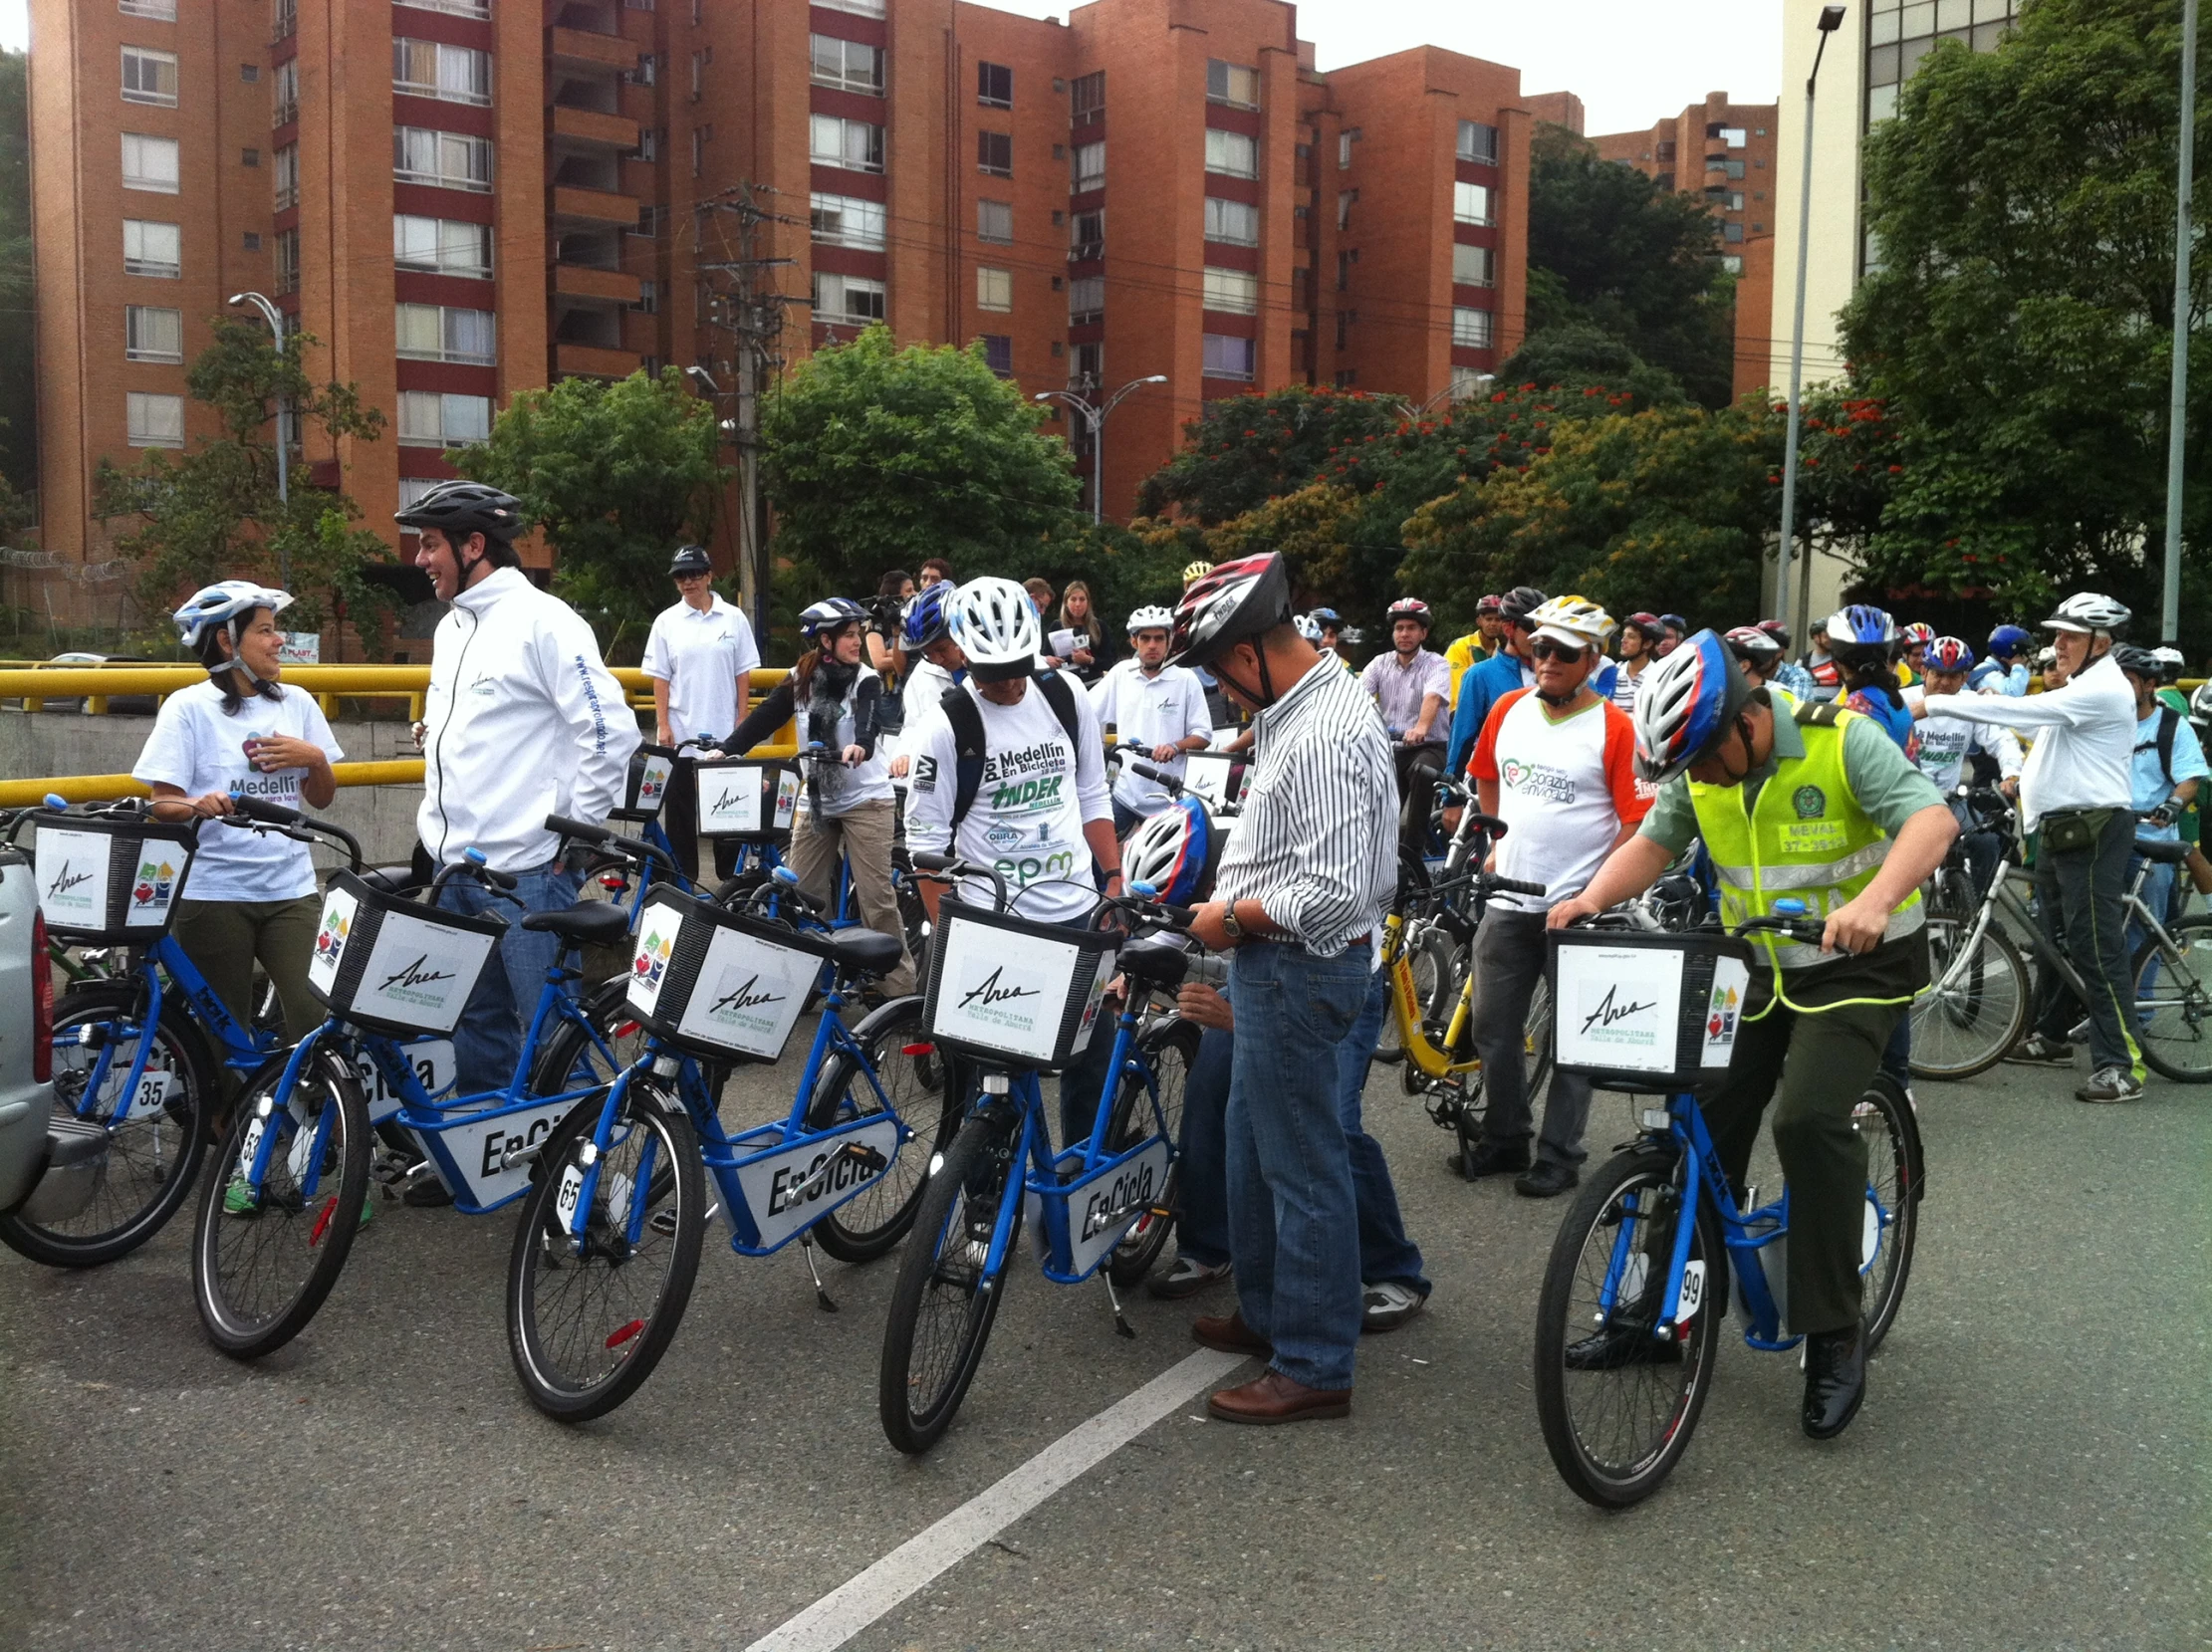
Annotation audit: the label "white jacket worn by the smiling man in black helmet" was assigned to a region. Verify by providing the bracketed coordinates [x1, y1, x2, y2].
[416, 569, 639, 871]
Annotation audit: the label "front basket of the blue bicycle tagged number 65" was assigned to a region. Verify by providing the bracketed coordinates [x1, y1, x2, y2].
[626, 887, 830, 1062]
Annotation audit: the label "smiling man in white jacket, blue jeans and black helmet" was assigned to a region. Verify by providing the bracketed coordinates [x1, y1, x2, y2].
[396, 482, 639, 1094]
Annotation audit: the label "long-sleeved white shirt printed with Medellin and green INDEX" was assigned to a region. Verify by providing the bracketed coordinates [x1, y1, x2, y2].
[907, 672, 1112, 924]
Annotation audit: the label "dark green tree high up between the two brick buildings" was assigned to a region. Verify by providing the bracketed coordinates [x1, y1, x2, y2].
[1529, 123, 1734, 407]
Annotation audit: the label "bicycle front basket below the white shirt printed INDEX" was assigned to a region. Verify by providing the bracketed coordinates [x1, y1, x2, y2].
[927, 895, 1121, 1070]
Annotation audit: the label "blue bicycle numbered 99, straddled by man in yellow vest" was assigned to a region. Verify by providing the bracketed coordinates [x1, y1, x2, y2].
[1535, 900, 1924, 1509]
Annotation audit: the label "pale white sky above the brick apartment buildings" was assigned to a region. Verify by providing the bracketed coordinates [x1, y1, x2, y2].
[0, 0, 1783, 132]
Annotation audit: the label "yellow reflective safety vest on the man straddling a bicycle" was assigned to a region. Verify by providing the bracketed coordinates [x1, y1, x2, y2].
[1690, 703, 1926, 971]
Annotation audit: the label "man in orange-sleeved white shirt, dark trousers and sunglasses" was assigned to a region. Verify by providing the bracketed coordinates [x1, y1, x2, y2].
[1455, 597, 1652, 1199]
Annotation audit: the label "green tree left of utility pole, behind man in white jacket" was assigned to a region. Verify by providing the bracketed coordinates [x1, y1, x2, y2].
[447, 367, 728, 659]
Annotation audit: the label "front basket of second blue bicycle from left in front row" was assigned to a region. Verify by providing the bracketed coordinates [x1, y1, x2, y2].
[308, 871, 507, 1038]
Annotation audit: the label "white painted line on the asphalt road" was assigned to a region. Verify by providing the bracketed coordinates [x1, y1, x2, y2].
[745, 1349, 1243, 1652]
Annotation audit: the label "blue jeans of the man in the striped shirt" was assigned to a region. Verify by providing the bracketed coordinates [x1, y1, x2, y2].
[1228, 940, 1371, 1389]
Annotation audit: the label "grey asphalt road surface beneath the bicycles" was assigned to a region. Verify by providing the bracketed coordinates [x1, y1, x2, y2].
[0, 1048, 2212, 1652]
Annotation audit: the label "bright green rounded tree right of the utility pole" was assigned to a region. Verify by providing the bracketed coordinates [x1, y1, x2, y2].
[761, 325, 1082, 597]
